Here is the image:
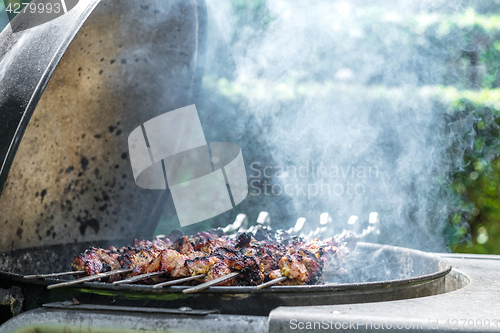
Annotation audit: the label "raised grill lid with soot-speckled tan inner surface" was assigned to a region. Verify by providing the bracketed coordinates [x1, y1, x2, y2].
[0, 0, 206, 250]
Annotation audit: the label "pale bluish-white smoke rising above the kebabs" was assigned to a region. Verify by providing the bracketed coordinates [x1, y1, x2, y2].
[196, 0, 480, 251]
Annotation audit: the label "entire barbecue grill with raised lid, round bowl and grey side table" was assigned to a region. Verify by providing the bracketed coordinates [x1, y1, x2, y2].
[0, 0, 500, 332]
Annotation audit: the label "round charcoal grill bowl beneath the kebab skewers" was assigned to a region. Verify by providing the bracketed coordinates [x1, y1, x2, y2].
[0, 239, 451, 315]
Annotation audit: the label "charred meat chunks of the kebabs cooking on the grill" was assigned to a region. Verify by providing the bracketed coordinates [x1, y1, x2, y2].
[71, 227, 356, 286]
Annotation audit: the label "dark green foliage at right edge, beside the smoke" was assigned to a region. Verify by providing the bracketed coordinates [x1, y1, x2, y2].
[443, 87, 500, 254]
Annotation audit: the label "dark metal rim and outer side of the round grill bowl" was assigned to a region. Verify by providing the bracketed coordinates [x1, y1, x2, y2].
[0, 242, 453, 316]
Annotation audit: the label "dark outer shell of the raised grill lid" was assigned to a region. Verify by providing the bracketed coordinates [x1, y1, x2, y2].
[0, 0, 99, 193]
